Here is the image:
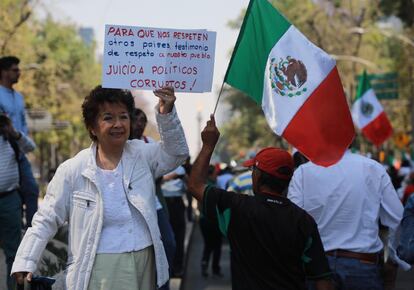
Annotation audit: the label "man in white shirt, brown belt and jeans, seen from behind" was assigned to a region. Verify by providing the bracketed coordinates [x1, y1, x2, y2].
[288, 152, 403, 290]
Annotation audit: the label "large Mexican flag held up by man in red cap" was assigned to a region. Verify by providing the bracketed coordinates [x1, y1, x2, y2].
[224, 0, 355, 166]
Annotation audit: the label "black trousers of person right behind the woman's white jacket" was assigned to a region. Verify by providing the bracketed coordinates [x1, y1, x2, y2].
[165, 196, 186, 275]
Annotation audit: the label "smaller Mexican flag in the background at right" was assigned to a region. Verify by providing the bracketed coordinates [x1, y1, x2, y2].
[352, 71, 392, 146]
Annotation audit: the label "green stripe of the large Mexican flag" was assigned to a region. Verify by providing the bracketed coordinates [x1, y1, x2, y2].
[224, 0, 291, 104]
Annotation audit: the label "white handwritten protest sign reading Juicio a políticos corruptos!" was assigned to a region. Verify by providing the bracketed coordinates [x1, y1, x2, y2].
[102, 25, 216, 93]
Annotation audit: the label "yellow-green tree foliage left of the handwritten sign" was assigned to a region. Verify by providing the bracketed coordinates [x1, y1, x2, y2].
[0, 0, 101, 184]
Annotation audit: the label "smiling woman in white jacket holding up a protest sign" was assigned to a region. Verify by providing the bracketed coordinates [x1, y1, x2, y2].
[12, 86, 188, 290]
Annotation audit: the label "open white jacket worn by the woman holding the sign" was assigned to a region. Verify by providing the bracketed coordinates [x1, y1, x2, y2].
[11, 109, 188, 290]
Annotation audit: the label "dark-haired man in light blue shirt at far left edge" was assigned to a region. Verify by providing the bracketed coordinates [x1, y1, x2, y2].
[0, 56, 39, 228]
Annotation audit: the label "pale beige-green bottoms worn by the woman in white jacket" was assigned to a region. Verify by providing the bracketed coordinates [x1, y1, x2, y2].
[88, 246, 157, 290]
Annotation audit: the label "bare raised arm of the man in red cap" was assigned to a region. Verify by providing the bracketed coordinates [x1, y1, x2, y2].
[188, 115, 220, 201]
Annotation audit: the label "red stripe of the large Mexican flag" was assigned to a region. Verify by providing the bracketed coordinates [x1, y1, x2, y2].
[282, 67, 355, 166]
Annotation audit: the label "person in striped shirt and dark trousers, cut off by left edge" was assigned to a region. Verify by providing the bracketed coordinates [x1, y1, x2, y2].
[0, 113, 35, 290]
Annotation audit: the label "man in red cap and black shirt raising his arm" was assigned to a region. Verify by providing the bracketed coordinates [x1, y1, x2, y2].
[188, 116, 332, 290]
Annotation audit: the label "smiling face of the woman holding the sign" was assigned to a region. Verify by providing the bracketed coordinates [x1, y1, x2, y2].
[92, 103, 131, 147]
